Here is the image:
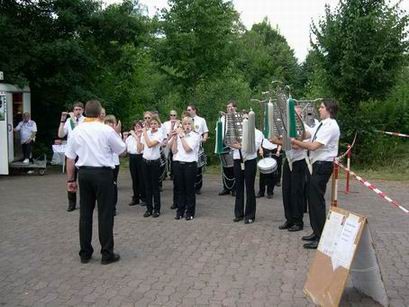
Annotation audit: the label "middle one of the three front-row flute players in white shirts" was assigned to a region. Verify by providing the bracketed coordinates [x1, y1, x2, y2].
[138, 116, 163, 217]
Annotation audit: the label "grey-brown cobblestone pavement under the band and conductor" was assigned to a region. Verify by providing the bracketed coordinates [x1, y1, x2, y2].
[0, 170, 409, 306]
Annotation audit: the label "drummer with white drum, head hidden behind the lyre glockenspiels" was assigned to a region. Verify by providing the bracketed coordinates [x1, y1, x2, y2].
[256, 139, 281, 199]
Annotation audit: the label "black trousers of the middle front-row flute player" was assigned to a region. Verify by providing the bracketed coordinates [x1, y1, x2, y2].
[143, 159, 160, 213]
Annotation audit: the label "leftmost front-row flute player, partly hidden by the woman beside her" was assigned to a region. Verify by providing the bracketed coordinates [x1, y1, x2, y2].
[125, 120, 146, 206]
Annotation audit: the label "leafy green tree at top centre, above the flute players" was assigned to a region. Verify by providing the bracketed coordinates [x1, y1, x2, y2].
[158, 0, 238, 89]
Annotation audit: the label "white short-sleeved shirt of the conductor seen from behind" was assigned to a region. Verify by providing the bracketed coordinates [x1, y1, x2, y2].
[65, 121, 126, 168]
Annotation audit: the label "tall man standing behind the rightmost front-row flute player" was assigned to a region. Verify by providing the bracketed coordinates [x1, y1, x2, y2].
[186, 104, 209, 194]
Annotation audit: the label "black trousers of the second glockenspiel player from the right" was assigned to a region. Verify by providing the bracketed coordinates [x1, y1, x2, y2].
[282, 159, 307, 226]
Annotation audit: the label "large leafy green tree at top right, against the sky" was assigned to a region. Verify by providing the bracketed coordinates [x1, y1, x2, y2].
[312, 0, 408, 106]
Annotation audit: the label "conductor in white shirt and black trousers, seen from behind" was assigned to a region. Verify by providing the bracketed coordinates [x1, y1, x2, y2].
[65, 100, 126, 264]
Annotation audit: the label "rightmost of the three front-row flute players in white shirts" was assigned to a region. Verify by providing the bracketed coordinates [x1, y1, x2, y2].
[168, 117, 201, 221]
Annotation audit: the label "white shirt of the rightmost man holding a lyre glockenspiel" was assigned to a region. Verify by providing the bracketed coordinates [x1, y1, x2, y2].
[310, 118, 341, 163]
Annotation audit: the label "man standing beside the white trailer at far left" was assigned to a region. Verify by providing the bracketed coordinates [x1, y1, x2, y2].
[14, 112, 37, 164]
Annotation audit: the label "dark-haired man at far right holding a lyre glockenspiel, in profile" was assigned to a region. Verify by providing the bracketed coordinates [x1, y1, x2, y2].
[292, 100, 340, 249]
